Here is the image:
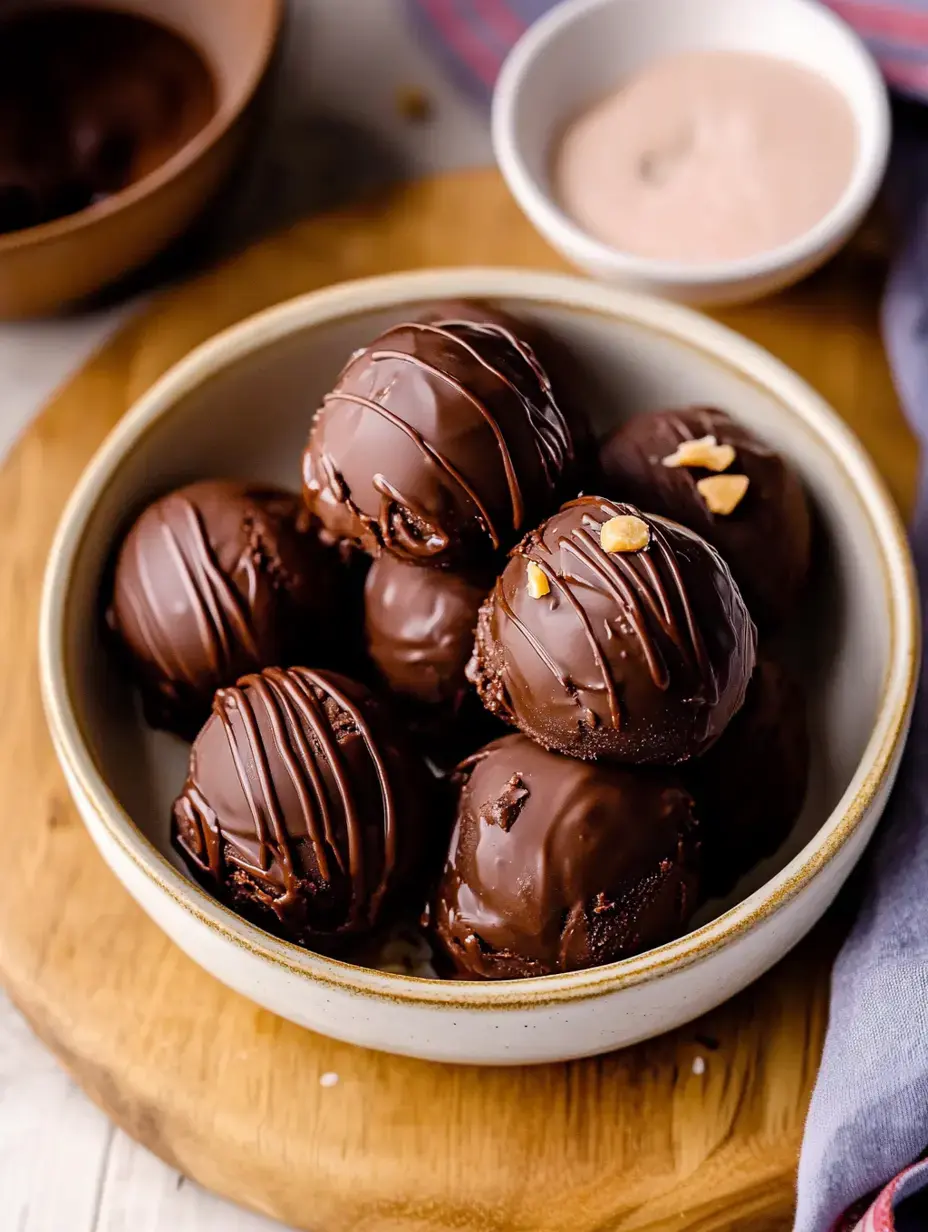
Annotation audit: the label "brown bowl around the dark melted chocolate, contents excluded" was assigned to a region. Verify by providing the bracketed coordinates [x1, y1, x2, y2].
[0, 0, 282, 318]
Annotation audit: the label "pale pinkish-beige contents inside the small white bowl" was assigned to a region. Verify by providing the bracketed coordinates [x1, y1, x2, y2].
[552, 52, 858, 262]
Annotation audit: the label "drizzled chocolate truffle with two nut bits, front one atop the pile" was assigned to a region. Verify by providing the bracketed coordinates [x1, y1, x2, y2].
[467, 496, 757, 765]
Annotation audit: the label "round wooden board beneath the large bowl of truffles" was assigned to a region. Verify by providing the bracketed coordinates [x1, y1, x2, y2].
[0, 171, 916, 1232]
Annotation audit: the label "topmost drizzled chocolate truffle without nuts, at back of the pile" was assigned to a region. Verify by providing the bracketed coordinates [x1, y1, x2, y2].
[303, 320, 574, 569]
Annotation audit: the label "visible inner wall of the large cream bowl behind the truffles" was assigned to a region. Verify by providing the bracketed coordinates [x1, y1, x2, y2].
[64, 295, 892, 960]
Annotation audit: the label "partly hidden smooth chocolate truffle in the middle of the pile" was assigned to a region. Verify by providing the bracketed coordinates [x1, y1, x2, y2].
[365, 556, 493, 713]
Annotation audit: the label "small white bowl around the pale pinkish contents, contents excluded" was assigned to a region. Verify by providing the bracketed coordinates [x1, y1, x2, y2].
[493, 0, 891, 304]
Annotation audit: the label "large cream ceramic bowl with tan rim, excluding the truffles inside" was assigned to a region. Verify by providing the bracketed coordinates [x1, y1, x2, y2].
[39, 270, 918, 1063]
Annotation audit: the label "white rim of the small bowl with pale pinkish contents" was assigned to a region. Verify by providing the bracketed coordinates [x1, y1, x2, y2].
[490, 0, 892, 288]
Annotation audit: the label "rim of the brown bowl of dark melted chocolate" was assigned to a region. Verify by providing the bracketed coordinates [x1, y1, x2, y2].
[0, 0, 285, 257]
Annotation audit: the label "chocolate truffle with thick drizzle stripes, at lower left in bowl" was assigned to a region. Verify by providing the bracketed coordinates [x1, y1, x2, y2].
[174, 668, 435, 945]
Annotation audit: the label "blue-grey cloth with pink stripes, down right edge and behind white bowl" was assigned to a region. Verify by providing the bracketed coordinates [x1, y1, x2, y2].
[407, 0, 928, 1232]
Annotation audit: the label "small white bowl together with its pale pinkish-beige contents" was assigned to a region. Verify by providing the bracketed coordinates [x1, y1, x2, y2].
[493, 0, 890, 303]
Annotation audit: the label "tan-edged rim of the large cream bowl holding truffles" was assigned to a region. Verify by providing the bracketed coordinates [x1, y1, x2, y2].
[38, 267, 921, 1010]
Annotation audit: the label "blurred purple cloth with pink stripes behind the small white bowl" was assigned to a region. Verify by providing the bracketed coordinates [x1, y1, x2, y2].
[409, 0, 928, 97]
